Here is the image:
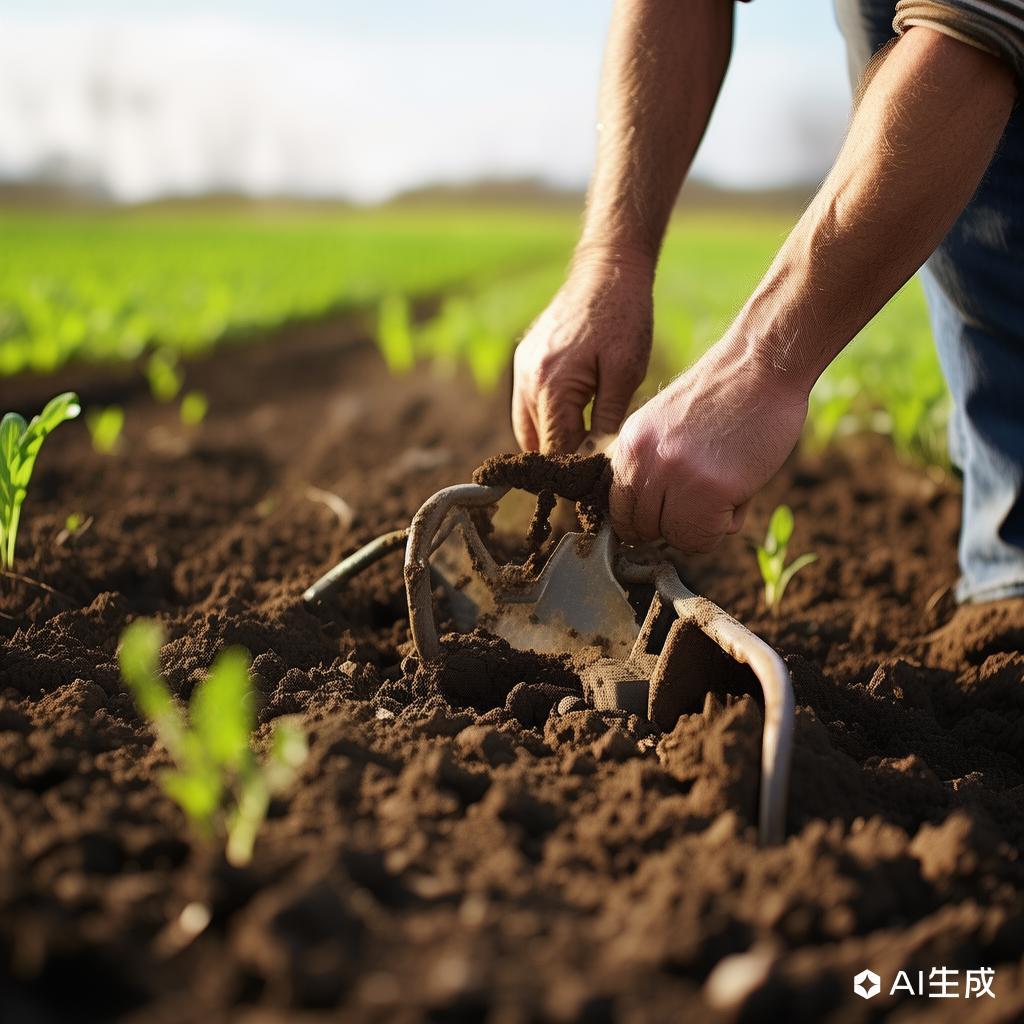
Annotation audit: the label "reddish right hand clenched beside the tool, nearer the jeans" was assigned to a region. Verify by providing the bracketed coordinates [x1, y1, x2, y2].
[610, 339, 807, 552]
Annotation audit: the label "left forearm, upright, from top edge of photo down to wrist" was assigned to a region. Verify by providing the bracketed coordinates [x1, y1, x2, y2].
[578, 0, 732, 271]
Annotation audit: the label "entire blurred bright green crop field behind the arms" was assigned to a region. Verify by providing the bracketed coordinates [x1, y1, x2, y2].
[0, 208, 945, 464]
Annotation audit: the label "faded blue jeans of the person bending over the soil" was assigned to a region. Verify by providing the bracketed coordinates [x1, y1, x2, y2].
[836, 0, 1024, 601]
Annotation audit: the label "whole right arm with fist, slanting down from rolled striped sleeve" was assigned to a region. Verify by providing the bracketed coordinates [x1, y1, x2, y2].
[611, 28, 1015, 551]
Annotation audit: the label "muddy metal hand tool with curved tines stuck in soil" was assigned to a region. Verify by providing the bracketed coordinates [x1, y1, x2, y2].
[304, 437, 794, 844]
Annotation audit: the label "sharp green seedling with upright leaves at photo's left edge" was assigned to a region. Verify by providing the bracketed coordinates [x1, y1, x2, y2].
[0, 391, 82, 569]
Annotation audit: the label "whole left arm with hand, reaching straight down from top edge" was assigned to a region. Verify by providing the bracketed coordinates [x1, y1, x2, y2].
[512, 0, 733, 451]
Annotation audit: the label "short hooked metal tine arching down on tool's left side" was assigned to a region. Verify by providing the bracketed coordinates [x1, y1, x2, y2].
[406, 483, 509, 662]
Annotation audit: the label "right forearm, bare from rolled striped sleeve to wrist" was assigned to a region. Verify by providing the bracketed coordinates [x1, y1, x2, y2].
[727, 29, 1015, 390]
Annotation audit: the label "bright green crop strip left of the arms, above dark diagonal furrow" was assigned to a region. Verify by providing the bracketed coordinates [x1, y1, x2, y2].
[0, 213, 570, 376]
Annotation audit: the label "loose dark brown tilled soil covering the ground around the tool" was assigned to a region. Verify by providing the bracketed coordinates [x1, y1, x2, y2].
[0, 315, 1024, 1024]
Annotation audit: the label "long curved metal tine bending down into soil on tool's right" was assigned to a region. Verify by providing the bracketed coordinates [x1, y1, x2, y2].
[618, 559, 795, 846]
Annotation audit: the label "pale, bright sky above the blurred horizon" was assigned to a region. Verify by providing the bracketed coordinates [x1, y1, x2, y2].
[0, 0, 850, 202]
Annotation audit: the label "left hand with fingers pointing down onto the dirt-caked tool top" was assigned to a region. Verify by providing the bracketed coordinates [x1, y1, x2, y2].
[512, 256, 654, 452]
